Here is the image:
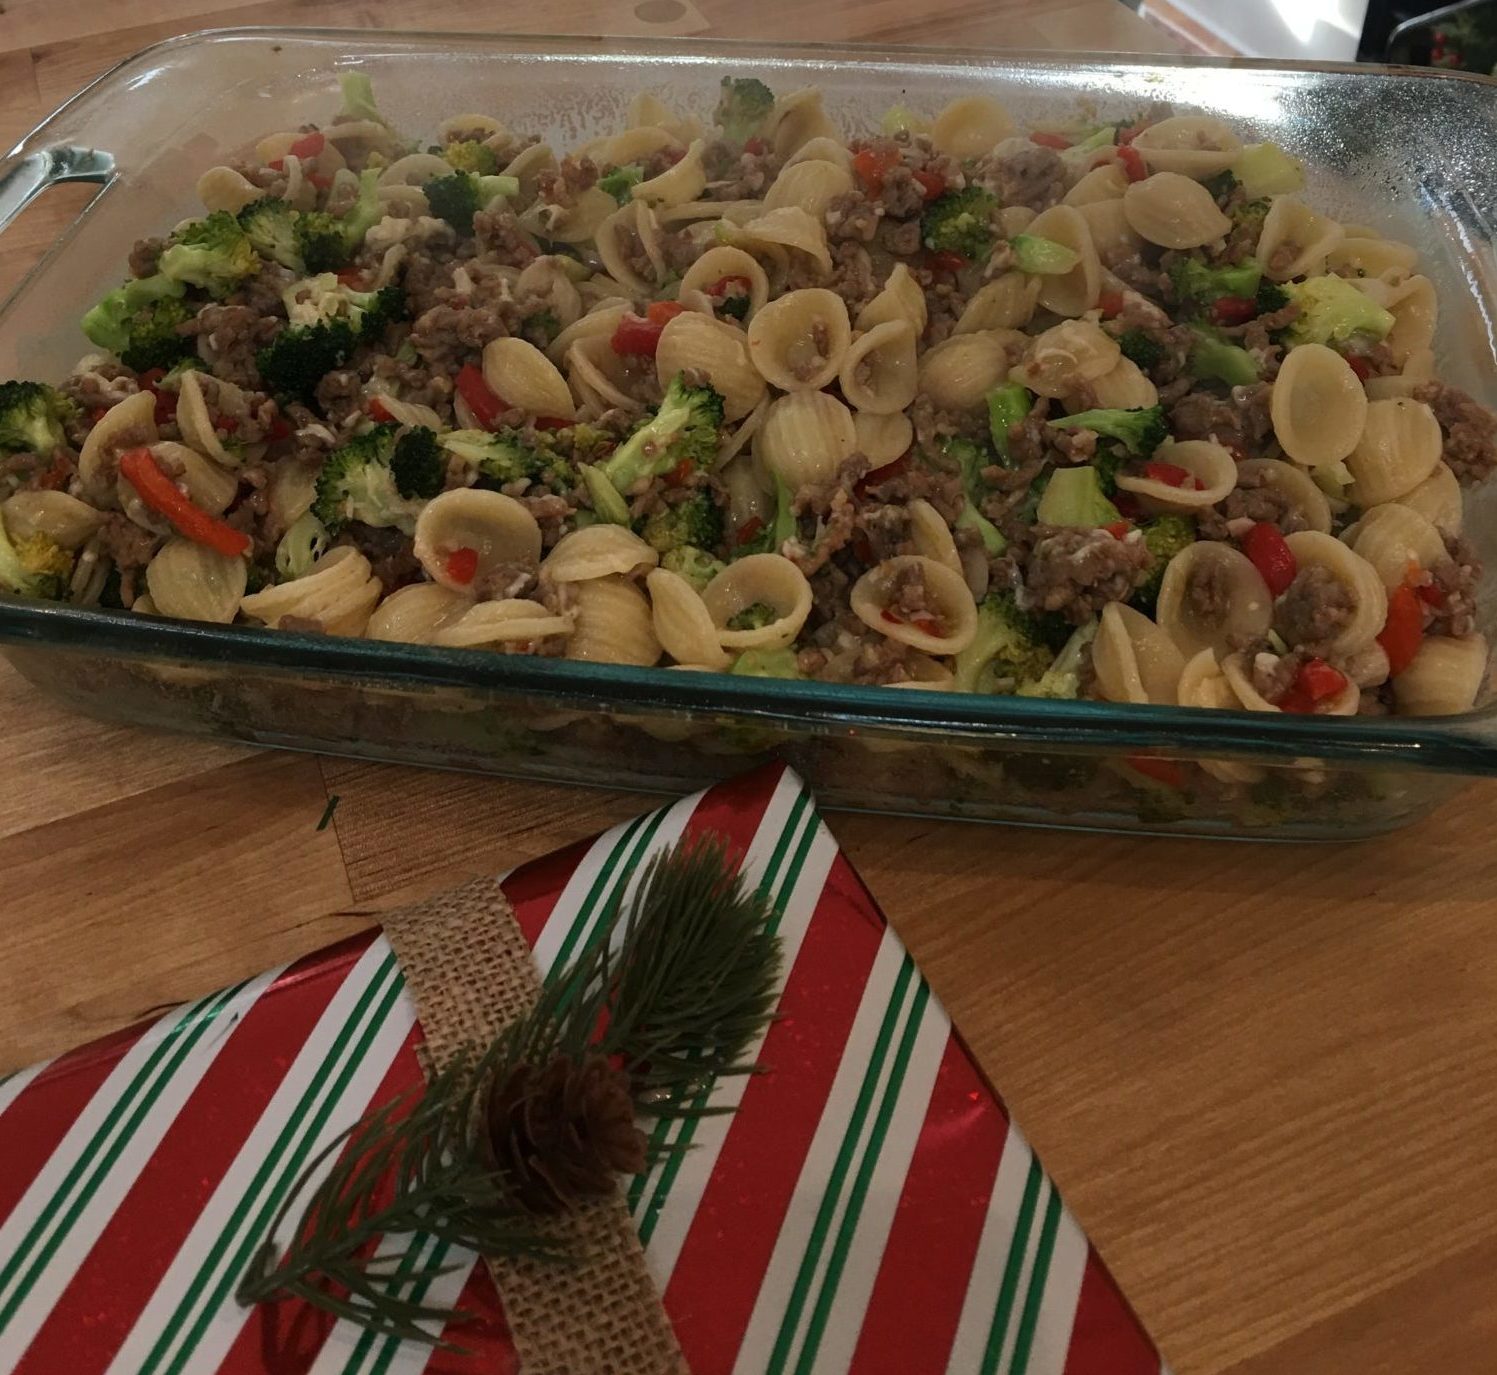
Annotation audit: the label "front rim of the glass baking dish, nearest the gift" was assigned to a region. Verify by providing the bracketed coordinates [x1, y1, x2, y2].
[0, 597, 1497, 774]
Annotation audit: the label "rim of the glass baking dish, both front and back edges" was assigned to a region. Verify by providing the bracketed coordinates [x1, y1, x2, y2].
[0, 25, 1497, 774]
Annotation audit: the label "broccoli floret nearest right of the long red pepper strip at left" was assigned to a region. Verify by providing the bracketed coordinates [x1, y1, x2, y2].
[311, 425, 443, 534]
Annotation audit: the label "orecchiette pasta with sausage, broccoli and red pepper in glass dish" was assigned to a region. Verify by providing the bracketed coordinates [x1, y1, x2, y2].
[0, 73, 1497, 730]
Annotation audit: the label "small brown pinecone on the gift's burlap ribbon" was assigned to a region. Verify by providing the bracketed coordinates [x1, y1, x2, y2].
[488, 1055, 645, 1213]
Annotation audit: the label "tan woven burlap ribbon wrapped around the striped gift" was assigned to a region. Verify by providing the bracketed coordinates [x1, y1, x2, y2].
[382, 878, 687, 1375]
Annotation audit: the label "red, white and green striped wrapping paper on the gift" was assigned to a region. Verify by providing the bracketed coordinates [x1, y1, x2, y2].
[0, 768, 1162, 1375]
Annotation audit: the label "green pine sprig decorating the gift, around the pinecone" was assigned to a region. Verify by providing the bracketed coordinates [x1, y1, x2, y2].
[237, 838, 780, 1345]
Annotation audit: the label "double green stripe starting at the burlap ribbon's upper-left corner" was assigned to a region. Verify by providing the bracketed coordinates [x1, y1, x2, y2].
[136, 952, 404, 1375]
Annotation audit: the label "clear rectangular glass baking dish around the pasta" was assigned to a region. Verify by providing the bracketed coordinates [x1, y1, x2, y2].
[0, 28, 1497, 839]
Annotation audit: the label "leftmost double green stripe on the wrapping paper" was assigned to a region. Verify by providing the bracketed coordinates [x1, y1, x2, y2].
[0, 980, 249, 1332]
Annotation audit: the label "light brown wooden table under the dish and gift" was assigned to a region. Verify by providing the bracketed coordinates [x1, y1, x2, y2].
[0, 0, 1497, 1375]
